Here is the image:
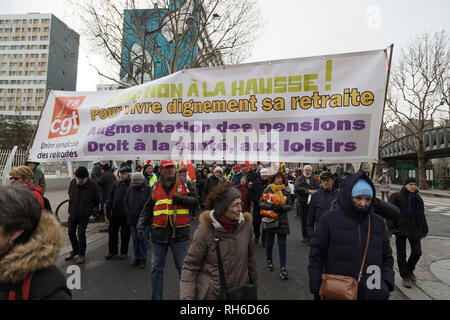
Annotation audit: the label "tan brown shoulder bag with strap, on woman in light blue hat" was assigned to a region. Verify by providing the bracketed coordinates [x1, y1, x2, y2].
[319, 214, 370, 300]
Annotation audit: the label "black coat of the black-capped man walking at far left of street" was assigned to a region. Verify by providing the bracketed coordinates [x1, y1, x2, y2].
[69, 178, 100, 220]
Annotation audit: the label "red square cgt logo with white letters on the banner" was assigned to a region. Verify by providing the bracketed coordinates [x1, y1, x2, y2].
[48, 96, 86, 139]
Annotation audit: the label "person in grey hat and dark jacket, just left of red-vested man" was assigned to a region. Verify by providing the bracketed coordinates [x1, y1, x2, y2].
[125, 172, 152, 269]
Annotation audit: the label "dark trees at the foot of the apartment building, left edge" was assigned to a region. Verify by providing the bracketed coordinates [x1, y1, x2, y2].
[0, 116, 34, 150]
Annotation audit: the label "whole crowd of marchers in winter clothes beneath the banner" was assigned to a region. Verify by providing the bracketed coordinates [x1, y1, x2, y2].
[0, 160, 428, 300]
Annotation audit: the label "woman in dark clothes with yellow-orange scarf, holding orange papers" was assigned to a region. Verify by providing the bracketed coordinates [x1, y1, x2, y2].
[259, 171, 293, 280]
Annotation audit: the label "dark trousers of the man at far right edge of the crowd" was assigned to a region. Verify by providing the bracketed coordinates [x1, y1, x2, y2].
[395, 234, 422, 279]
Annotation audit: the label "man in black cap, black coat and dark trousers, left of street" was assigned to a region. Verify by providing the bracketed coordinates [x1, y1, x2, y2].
[65, 167, 100, 264]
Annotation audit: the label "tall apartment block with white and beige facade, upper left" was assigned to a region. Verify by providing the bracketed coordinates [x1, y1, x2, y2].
[0, 13, 79, 123]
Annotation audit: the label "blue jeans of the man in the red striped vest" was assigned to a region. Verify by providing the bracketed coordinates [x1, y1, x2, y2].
[151, 241, 189, 300]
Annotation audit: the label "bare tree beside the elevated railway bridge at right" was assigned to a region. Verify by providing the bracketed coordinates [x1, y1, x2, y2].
[385, 31, 450, 189]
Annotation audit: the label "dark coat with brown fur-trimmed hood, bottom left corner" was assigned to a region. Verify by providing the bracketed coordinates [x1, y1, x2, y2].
[0, 211, 72, 300]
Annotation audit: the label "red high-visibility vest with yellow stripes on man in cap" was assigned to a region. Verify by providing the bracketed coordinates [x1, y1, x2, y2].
[153, 178, 189, 228]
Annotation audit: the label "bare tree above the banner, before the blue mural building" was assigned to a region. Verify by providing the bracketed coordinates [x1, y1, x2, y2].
[72, 0, 263, 87]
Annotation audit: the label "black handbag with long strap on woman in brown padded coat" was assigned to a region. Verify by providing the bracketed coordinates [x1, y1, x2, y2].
[214, 233, 258, 300]
